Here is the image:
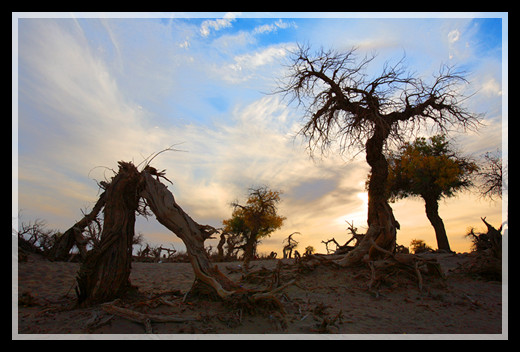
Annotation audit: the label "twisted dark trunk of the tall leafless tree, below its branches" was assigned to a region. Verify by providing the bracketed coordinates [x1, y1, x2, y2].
[338, 124, 399, 266]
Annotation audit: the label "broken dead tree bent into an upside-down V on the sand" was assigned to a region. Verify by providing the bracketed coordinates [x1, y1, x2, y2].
[60, 157, 292, 309]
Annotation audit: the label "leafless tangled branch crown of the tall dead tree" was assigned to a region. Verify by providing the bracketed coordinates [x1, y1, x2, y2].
[278, 45, 480, 157]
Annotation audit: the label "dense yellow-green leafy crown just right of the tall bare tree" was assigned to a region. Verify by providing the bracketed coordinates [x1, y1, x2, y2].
[387, 135, 478, 201]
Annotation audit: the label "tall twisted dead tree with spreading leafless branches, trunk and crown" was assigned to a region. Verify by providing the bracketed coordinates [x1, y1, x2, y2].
[277, 45, 480, 266]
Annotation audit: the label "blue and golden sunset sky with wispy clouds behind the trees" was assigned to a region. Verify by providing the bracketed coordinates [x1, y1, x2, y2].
[12, 12, 508, 256]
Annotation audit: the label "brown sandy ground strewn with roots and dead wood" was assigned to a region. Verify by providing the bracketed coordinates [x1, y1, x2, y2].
[13, 254, 507, 339]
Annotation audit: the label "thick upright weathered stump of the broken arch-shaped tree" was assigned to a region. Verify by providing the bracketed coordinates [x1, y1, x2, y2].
[76, 162, 140, 306]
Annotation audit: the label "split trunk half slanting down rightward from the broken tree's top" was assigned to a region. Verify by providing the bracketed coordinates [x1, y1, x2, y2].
[141, 170, 237, 298]
